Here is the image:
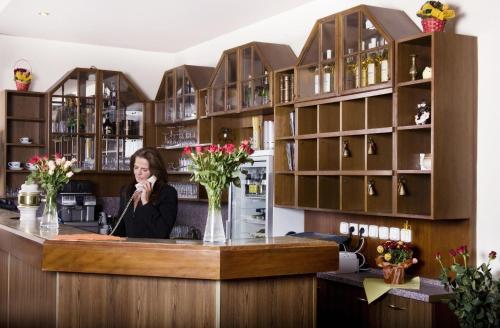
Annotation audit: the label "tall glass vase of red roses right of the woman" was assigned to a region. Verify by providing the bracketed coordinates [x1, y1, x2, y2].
[184, 140, 253, 242]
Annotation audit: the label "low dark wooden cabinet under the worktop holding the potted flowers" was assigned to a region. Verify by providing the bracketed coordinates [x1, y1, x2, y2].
[317, 279, 458, 328]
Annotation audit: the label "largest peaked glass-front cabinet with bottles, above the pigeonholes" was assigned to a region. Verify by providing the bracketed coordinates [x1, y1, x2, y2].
[296, 5, 419, 101]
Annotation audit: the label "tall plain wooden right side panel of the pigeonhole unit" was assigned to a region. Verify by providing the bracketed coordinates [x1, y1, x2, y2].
[432, 33, 477, 218]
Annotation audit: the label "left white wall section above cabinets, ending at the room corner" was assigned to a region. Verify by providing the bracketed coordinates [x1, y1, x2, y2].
[0, 35, 174, 99]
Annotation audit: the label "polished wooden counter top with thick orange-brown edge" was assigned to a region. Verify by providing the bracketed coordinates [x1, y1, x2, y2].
[0, 210, 338, 280]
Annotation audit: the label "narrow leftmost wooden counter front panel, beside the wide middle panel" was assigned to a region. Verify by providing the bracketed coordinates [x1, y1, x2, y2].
[9, 256, 56, 327]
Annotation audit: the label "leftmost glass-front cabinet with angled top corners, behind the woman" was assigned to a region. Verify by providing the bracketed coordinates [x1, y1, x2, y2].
[49, 68, 146, 171]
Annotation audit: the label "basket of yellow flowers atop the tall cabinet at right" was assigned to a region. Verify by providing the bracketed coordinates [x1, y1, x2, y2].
[417, 1, 455, 32]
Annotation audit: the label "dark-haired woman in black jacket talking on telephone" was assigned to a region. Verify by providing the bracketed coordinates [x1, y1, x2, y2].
[113, 148, 177, 238]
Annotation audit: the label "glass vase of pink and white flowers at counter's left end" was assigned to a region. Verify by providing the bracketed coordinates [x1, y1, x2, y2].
[28, 154, 80, 229]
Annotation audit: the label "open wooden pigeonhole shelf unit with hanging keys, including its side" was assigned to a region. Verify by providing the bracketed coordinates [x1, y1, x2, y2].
[275, 30, 477, 219]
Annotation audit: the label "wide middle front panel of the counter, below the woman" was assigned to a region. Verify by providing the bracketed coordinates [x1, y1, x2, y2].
[58, 273, 215, 328]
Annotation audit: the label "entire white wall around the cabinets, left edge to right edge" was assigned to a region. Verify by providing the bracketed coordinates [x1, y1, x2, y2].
[0, 0, 500, 274]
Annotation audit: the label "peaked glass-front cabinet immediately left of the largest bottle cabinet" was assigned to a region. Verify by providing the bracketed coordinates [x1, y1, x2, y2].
[208, 42, 296, 116]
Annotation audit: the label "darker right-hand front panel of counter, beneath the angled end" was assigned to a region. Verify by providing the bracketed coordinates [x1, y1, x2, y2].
[220, 275, 316, 327]
